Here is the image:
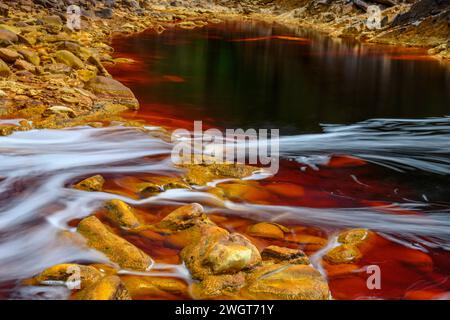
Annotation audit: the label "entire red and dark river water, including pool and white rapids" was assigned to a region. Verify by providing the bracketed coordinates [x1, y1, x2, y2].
[0, 22, 450, 299]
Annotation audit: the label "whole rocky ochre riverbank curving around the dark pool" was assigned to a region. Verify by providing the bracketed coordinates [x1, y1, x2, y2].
[0, 0, 450, 135]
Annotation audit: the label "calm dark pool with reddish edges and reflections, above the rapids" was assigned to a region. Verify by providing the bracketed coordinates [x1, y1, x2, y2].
[110, 22, 450, 134]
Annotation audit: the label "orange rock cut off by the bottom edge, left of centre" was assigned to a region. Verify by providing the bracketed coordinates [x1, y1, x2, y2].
[74, 276, 131, 300]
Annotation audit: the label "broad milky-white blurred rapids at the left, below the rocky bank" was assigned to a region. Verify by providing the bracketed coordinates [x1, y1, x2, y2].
[0, 127, 176, 281]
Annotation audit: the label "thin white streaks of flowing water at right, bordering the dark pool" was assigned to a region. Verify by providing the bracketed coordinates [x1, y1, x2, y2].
[280, 117, 450, 175]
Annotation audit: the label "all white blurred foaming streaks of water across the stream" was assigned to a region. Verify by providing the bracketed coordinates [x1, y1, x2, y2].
[0, 118, 450, 286]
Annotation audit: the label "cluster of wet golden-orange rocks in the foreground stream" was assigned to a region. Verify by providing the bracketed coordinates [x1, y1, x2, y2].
[25, 165, 380, 300]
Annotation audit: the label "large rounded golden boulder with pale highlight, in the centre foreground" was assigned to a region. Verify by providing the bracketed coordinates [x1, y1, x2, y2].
[181, 226, 261, 279]
